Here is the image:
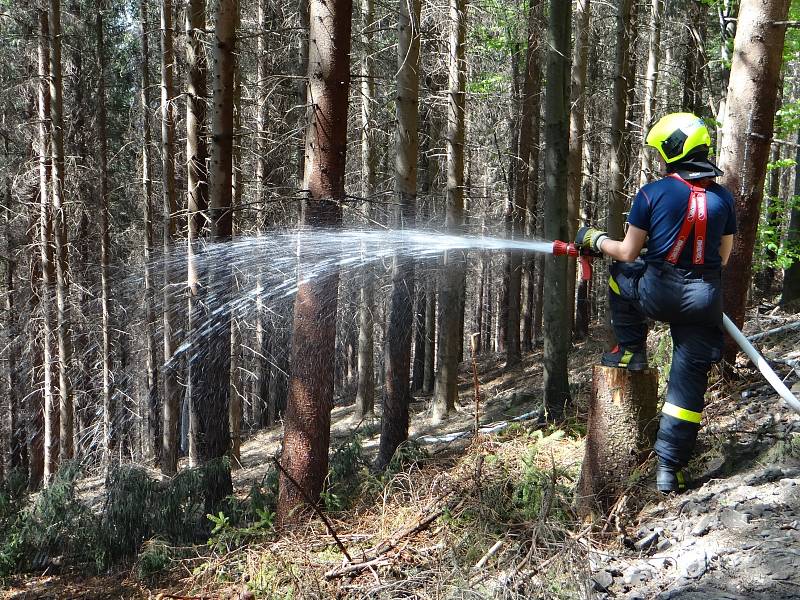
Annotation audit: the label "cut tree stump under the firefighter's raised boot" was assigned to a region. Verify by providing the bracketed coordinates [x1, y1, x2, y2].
[577, 365, 658, 517]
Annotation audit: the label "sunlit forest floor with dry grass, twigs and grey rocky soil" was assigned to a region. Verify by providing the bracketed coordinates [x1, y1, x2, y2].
[2, 311, 800, 600]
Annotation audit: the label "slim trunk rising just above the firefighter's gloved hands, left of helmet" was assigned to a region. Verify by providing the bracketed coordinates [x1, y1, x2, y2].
[606, 0, 633, 240]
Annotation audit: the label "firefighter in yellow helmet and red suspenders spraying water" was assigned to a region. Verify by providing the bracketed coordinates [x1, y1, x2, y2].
[575, 113, 736, 493]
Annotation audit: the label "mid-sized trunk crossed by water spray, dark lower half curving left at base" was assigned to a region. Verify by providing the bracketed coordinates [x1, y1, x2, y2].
[375, 0, 421, 469]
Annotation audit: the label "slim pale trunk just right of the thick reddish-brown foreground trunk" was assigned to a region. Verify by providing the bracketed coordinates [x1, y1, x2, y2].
[354, 0, 378, 421]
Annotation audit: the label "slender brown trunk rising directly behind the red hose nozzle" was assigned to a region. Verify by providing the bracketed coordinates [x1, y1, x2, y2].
[567, 0, 591, 333]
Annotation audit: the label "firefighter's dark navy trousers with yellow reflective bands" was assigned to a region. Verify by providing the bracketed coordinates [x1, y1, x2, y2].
[609, 260, 723, 468]
